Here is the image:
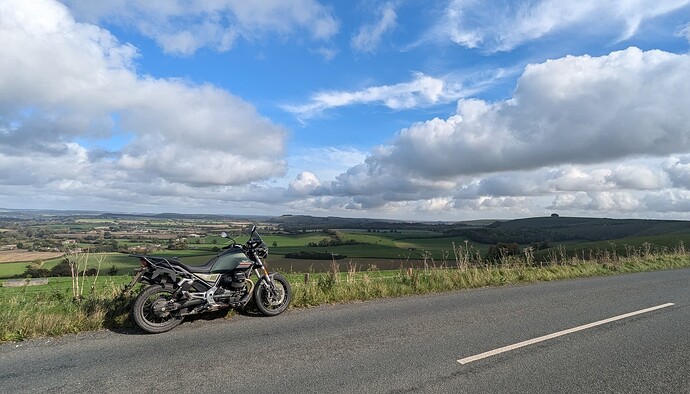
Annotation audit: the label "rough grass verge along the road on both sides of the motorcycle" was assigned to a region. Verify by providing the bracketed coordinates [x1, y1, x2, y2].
[0, 252, 690, 342]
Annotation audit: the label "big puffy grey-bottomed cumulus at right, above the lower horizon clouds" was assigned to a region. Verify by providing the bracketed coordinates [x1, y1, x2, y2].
[370, 48, 690, 178]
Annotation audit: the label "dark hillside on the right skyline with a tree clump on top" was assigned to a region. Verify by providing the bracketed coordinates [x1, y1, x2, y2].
[445, 217, 690, 244]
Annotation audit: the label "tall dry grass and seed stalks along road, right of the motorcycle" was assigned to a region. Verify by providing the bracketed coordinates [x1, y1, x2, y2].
[291, 242, 690, 307]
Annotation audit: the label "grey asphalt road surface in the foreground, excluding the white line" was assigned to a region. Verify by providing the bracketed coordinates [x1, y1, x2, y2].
[0, 269, 690, 393]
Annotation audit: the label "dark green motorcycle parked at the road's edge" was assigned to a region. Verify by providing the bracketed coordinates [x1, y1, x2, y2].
[128, 226, 292, 333]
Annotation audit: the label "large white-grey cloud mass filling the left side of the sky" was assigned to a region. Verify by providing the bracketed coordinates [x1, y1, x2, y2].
[0, 0, 286, 209]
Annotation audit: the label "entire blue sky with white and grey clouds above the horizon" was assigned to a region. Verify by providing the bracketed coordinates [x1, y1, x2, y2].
[0, 0, 690, 221]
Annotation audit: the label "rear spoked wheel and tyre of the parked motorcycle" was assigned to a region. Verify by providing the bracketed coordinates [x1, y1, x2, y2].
[132, 285, 182, 334]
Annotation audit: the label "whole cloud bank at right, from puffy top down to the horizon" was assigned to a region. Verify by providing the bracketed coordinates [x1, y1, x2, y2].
[306, 47, 690, 217]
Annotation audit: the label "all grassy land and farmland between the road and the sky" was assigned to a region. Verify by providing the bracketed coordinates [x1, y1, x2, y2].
[0, 209, 690, 341]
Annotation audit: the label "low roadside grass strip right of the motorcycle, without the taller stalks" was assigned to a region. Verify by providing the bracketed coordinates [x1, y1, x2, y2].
[288, 255, 690, 307]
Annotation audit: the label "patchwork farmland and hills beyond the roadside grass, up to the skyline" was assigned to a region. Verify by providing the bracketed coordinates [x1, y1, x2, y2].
[0, 214, 690, 278]
